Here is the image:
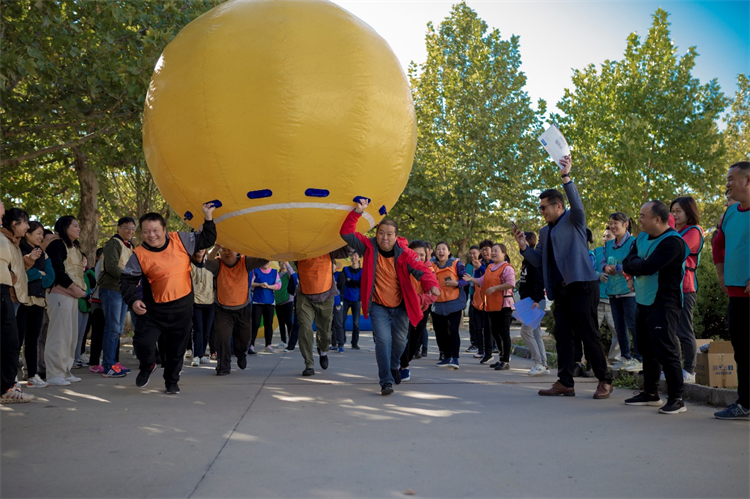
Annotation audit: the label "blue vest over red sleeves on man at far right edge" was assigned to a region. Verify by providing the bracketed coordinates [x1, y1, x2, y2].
[721, 203, 750, 288]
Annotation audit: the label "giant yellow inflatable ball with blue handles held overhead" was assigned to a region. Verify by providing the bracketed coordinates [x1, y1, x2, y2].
[143, 0, 416, 260]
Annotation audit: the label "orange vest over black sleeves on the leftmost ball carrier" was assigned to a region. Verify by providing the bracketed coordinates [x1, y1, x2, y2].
[134, 232, 193, 303]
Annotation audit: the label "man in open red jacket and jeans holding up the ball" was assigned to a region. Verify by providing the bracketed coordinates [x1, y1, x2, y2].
[340, 198, 440, 395]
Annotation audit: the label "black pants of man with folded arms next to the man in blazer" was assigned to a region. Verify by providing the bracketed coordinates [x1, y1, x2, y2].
[635, 301, 683, 399]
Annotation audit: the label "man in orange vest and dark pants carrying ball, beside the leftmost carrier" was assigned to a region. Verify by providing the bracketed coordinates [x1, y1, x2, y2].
[206, 244, 268, 376]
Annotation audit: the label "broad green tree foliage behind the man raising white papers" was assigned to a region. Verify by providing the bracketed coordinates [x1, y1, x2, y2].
[545, 9, 727, 229]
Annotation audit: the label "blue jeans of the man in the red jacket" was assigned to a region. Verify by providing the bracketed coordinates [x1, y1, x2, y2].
[370, 303, 409, 387]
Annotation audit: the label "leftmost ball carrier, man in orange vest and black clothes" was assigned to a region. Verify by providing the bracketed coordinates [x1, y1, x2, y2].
[120, 203, 216, 394]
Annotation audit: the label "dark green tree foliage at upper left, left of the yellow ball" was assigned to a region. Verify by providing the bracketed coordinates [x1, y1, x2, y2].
[0, 0, 220, 258]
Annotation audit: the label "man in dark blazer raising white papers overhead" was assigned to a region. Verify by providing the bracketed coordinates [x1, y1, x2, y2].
[513, 156, 612, 399]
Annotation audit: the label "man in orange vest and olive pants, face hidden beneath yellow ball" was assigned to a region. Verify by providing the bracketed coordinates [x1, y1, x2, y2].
[297, 246, 349, 376]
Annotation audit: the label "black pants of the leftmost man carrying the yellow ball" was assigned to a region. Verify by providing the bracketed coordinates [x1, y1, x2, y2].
[133, 305, 193, 386]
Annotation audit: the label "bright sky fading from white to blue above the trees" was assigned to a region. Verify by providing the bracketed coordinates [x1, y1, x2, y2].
[333, 0, 750, 118]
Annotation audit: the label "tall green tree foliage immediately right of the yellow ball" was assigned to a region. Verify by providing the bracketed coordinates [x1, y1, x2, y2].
[392, 3, 545, 254]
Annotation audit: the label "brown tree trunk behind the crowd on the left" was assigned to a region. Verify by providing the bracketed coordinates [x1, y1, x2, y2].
[71, 145, 99, 267]
